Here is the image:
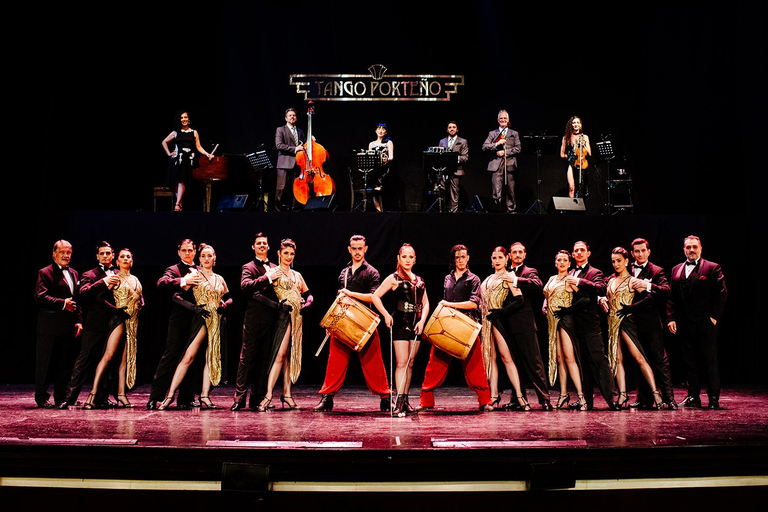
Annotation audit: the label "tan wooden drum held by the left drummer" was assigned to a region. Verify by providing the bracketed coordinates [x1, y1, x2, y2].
[320, 295, 379, 352]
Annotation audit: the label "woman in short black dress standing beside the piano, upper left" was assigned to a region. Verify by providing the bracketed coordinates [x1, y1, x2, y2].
[162, 111, 213, 212]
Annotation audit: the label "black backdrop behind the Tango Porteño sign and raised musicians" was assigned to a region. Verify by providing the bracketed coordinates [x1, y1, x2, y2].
[2, 1, 766, 388]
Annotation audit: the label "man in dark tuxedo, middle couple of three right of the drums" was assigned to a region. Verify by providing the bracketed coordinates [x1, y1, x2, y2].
[559, 241, 618, 410]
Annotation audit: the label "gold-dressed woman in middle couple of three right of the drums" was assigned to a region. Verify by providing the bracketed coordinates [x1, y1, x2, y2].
[544, 250, 587, 411]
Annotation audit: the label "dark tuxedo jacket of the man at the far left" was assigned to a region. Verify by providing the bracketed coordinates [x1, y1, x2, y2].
[35, 263, 82, 336]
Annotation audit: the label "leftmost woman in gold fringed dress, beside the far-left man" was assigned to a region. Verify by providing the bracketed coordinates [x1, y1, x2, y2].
[83, 249, 144, 409]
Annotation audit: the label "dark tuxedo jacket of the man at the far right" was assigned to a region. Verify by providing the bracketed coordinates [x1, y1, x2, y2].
[667, 258, 728, 322]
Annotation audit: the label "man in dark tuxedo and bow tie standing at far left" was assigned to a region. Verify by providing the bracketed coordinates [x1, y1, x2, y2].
[35, 240, 83, 408]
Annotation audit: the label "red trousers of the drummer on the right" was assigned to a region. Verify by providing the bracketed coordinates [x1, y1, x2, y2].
[420, 342, 491, 407]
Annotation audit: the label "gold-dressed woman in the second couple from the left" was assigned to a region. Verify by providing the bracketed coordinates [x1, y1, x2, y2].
[157, 244, 232, 411]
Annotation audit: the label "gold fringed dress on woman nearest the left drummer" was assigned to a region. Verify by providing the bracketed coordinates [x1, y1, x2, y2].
[267, 270, 304, 384]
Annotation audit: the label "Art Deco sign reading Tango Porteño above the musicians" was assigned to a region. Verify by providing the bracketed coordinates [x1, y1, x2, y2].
[289, 64, 464, 101]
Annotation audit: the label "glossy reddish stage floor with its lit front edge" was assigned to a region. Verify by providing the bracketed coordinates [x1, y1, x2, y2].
[0, 384, 768, 510]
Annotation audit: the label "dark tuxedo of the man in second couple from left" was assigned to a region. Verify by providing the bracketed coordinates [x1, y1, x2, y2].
[149, 262, 202, 404]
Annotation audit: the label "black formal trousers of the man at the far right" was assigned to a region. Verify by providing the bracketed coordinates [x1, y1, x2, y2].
[677, 318, 720, 397]
